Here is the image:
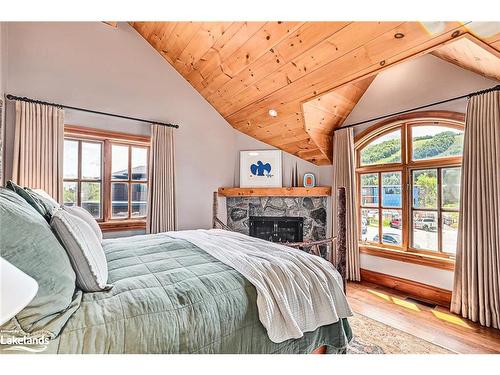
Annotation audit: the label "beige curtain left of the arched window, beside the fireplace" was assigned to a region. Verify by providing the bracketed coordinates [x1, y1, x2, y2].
[332, 129, 361, 281]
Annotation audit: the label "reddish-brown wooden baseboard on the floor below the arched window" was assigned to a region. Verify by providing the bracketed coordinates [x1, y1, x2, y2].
[361, 269, 451, 307]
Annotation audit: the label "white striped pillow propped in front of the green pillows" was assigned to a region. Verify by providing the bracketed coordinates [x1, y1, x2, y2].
[50, 210, 112, 292]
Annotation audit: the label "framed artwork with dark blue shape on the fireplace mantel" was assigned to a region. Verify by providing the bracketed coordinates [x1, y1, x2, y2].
[240, 150, 283, 187]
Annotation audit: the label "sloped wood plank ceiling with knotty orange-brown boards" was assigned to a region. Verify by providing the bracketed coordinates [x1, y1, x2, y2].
[130, 22, 500, 165]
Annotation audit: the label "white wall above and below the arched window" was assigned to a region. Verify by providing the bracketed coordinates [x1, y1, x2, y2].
[345, 55, 496, 290]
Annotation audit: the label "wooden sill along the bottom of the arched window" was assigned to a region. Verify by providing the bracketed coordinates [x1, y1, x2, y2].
[359, 243, 455, 271]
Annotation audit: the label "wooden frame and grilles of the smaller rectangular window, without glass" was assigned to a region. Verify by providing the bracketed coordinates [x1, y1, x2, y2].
[64, 124, 151, 232]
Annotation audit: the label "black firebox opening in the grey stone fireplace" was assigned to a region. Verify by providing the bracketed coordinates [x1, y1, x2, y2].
[249, 216, 304, 242]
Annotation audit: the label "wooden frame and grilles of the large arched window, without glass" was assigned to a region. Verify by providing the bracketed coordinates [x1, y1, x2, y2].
[355, 111, 465, 270]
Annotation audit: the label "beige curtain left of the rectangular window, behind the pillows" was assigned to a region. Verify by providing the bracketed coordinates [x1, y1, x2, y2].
[12, 101, 64, 202]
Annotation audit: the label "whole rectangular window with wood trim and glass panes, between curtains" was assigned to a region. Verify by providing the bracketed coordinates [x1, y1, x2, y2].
[64, 125, 149, 230]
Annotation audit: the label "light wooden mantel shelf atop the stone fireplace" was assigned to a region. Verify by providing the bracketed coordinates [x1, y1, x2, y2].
[219, 186, 332, 197]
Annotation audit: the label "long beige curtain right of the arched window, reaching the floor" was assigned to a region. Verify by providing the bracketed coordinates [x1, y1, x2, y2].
[451, 90, 500, 328]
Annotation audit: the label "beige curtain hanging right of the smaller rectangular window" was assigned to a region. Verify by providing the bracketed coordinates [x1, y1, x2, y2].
[146, 124, 177, 233]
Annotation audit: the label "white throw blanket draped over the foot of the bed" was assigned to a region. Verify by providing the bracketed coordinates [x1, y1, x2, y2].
[166, 229, 352, 343]
